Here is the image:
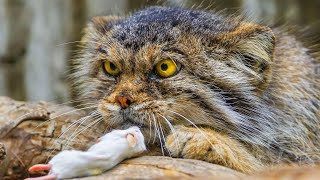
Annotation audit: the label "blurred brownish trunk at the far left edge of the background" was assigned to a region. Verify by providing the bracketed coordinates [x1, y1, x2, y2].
[0, 0, 30, 99]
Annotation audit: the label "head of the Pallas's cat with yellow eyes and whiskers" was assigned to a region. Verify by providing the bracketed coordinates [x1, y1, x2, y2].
[74, 7, 274, 145]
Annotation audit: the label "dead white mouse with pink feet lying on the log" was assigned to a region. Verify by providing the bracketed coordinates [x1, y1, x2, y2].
[29, 126, 146, 180]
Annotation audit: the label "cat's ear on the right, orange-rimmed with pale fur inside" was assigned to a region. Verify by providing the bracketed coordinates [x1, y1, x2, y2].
[219, 23, 275, 91]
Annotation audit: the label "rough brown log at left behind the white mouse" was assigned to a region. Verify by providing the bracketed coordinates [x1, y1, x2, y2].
[0, 97, 104, 179]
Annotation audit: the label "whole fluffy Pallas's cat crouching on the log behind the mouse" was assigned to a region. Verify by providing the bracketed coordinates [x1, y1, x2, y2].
[73, 7, 320, 172]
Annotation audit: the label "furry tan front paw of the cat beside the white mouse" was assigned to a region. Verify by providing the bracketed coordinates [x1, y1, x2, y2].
[166, 127, 262, 172]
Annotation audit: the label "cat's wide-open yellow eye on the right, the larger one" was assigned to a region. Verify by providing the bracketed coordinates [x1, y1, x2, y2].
[156, 59, 178, 77]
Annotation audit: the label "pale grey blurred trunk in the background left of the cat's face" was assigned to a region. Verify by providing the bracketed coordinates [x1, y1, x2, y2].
[25, 0, 72, 101]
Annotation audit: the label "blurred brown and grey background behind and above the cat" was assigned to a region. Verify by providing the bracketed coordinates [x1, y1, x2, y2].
[0, 0, 320, 103]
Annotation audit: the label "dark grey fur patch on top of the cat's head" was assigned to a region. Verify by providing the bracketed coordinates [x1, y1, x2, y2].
[112, 7, 237, 51]
